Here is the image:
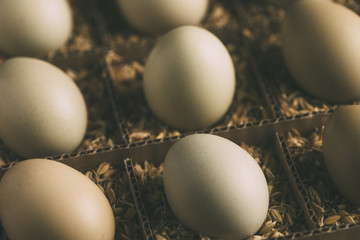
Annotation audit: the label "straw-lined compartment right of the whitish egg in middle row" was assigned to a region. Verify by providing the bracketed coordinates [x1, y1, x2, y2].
[0, 58, 124, 165]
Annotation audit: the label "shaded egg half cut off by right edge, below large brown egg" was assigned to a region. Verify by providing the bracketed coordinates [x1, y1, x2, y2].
[323, 105, 360, 204]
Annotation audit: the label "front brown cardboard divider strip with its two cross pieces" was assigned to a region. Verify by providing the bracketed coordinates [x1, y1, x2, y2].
[2, 112, 360, 240]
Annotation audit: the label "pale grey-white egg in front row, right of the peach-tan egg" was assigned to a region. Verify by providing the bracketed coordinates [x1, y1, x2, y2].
[163, 134, 269, 239]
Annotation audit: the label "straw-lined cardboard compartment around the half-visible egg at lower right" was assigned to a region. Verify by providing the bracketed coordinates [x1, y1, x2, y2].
[277, 111, 360, 239]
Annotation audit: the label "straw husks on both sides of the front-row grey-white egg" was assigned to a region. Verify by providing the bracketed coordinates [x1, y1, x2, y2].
[134, 144, 305, 240]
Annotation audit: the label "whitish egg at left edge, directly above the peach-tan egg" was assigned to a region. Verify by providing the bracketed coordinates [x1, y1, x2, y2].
[0, 57, 87, 158]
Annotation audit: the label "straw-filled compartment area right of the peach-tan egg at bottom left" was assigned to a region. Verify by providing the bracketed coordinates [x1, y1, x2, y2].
[0, 159, 144, 240]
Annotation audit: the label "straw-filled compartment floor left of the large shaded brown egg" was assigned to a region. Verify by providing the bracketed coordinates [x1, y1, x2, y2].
[246, 0, 360, 116]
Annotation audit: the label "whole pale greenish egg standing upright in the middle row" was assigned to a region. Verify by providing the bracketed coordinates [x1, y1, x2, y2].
[143, 26, 235, 130]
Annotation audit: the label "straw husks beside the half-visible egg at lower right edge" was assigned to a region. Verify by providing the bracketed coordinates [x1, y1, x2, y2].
[287, 127, 360, 227]
